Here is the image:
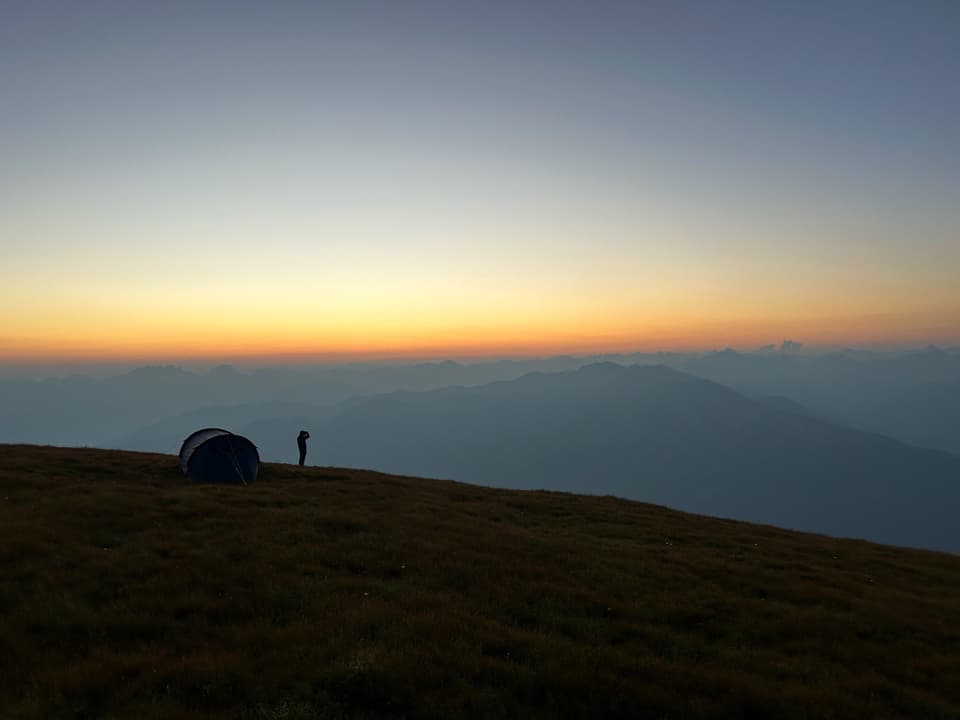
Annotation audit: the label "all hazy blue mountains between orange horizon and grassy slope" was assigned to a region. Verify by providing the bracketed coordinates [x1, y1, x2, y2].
[0, 347, 960, 551]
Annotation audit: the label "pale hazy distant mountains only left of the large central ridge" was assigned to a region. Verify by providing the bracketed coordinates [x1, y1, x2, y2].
[0, 356, 587, 452]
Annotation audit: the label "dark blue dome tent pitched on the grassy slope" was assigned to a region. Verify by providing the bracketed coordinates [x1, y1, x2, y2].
[180, 428, 260, 485]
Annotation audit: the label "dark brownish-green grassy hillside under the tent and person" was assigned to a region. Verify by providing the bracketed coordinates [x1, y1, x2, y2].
[0, 446, 960, 719]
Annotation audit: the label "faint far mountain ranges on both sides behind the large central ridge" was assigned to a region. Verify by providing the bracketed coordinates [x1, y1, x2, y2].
[0, 346, 960, 455]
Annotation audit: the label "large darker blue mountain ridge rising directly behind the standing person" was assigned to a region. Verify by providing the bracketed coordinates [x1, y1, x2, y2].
[244, 363, 960, 551]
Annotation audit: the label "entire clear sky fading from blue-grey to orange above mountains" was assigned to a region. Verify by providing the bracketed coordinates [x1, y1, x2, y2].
[0, 0, 960, 362]
